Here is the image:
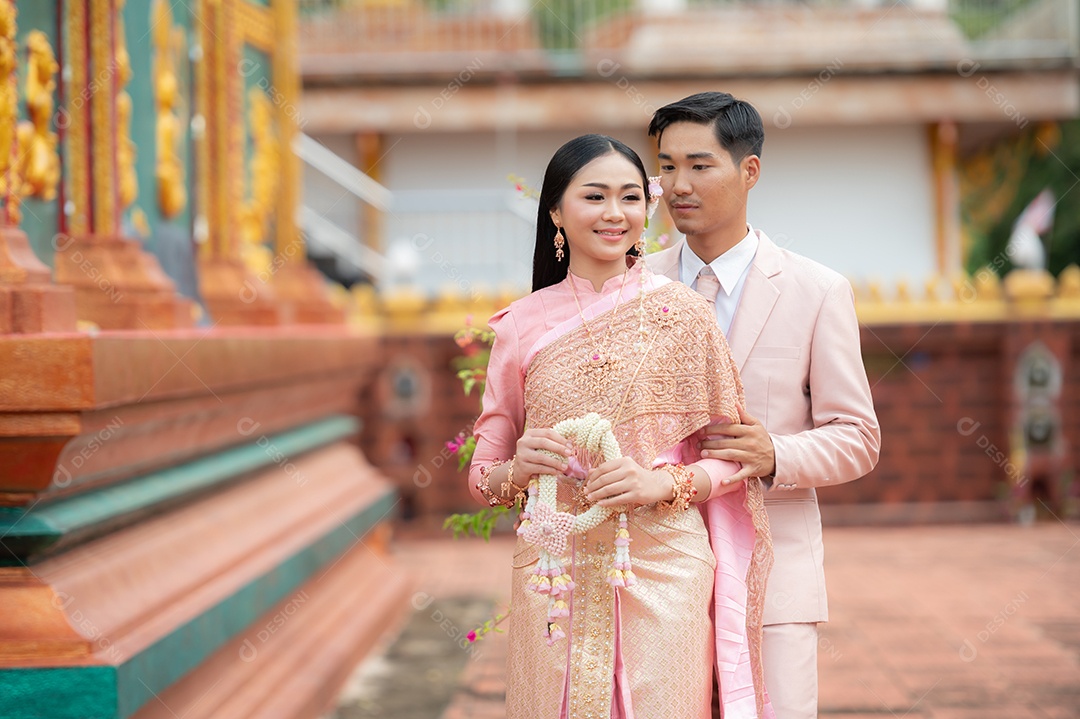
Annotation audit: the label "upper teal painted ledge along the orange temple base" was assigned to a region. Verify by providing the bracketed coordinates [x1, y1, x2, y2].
[0, 416, 360, 566]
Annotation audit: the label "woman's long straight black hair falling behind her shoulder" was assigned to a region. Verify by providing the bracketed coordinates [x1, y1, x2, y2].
[532, 135, 649, 291]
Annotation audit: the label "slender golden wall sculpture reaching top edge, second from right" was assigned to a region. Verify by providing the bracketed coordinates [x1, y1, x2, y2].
[153, 0, 188, 217]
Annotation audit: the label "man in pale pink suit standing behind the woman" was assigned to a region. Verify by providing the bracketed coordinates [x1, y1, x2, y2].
[649, 93, 880, 719]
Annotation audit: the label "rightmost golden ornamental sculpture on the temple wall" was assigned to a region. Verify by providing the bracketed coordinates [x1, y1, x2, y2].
[240, 87, 280, 273]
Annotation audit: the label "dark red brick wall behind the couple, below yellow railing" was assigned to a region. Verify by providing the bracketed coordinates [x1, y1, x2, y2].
[362, 321, 1080, 521]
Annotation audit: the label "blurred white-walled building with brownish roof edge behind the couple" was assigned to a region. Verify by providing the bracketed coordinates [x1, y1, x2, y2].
[300, 0, 1080, 294]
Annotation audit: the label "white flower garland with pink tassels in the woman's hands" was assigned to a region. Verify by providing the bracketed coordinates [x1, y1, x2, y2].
[517, 412, 637, 646]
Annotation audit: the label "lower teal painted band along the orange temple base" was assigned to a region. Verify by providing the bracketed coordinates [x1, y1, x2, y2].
[0, 489, 397, 719]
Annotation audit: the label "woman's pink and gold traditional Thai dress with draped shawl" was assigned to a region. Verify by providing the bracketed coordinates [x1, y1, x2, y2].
[470, 263, 772, 719]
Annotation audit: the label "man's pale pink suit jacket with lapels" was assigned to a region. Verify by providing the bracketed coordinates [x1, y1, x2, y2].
[648, 230, 881, 624]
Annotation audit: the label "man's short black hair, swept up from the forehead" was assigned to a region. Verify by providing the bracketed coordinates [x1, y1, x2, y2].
[649, 93, 765, 165]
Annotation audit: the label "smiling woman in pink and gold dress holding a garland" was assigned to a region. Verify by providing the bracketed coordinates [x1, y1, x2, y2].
[470, 135, 771, 719]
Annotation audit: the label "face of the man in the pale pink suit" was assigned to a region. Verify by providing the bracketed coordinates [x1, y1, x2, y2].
[660, 122, 759, 241]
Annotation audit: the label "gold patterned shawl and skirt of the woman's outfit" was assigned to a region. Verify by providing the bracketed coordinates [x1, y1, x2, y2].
[507, 276, 771, 719]
